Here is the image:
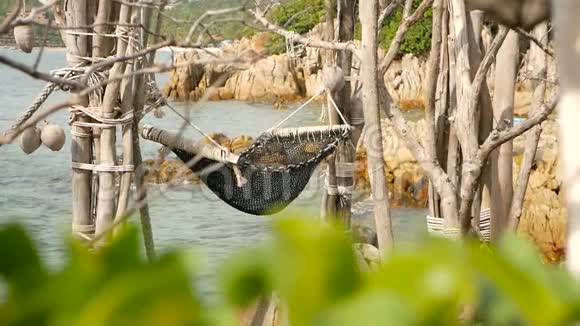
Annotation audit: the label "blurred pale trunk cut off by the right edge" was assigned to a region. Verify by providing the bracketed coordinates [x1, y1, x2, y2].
[553, 0, 580, 277]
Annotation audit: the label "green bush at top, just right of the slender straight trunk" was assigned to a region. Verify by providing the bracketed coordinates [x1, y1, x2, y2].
[355, 0, 433, 55]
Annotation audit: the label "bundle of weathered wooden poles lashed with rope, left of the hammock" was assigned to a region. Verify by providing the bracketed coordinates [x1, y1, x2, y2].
[54, 0, 153, 258]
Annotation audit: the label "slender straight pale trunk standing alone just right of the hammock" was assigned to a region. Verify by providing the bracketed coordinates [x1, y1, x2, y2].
[359, 0, 393, 253]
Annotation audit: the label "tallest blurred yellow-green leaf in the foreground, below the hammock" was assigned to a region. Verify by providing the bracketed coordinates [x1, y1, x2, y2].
[270, 218, 361, 325]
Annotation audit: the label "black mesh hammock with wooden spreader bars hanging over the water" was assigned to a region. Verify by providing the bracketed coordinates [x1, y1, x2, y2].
[142, 125, 350, 215]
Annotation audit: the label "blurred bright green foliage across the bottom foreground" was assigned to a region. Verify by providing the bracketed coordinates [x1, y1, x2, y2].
[0, 218, 580, 326]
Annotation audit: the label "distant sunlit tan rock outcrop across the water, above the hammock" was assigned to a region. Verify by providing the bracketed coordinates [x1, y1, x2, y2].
[163, 31, 426, 109]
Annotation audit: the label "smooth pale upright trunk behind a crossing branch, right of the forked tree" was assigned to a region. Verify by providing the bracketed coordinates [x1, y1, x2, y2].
[490, 31, 520, 239]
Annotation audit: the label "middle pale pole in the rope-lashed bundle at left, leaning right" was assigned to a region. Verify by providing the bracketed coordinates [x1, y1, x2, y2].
[95, 1, 132, 242]
